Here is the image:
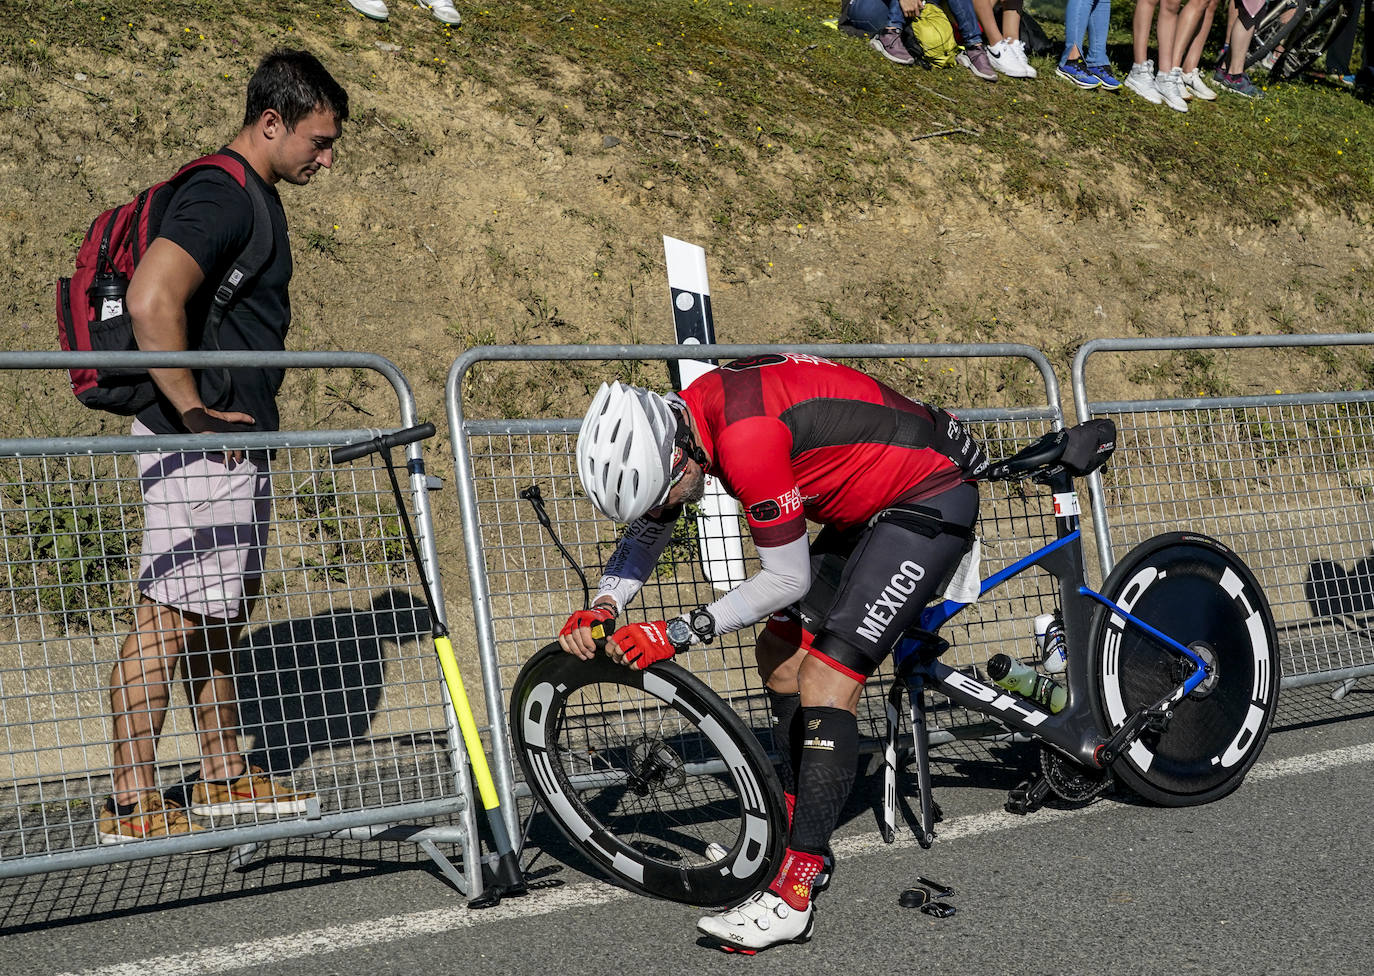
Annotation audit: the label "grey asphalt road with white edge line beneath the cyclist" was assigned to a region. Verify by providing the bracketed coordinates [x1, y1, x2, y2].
[0, 679, 1374, 976]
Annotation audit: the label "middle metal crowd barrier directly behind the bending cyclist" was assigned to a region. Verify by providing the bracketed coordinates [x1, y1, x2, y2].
[447, 345, 1062, 836]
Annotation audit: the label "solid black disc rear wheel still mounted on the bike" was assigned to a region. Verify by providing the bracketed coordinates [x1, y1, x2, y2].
[1088, 532, 1281, 807]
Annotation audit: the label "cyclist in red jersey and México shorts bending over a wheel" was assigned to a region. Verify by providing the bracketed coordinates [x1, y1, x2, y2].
[559, 355, 988, 950]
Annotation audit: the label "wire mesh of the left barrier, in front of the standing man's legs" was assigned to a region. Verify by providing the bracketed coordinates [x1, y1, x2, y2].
[0, 440, 458, 863]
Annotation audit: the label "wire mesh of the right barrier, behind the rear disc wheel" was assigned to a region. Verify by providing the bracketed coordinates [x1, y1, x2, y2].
[1090, 396, 1374, 678]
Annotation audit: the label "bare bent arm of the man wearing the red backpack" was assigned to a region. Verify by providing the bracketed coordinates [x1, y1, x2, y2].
[126, 238, 253, 433]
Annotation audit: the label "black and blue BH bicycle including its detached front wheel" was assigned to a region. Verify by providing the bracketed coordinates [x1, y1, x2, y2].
[510, 419, 1281, 906]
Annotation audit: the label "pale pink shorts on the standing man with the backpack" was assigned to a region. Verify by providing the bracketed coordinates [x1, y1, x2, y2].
[133, 421, 272, 620]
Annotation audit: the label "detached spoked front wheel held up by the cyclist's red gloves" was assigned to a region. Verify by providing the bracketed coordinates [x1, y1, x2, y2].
[511, 643, 787, 907]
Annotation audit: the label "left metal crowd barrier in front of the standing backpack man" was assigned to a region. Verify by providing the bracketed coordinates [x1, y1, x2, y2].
[0, 353, 482, 895]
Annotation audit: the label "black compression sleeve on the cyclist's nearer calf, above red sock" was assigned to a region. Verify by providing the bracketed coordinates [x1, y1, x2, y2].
[790, 707, 859, 858]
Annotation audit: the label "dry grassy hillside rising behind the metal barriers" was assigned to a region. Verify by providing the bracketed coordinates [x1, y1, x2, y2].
[0, 0, 1374, 429]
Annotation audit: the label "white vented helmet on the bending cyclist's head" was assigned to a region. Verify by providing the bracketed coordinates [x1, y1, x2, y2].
[577, 381, 677, 522]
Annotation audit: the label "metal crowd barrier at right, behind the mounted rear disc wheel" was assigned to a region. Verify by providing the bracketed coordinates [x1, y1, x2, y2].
[1073, 334, 1374, 694]
